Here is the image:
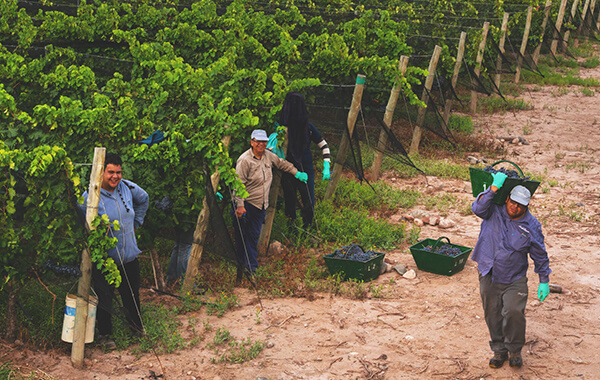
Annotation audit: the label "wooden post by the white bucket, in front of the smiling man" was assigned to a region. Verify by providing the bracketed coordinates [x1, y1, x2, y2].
[71, 148, 106, 368]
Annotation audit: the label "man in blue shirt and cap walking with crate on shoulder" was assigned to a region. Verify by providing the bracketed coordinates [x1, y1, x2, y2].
[471, 172, 552, 368]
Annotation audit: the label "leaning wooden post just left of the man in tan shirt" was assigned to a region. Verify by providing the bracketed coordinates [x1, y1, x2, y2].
[181, 131, 231, 295]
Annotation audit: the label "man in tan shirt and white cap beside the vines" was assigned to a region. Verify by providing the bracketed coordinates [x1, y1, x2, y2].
[233, 129, 308, 273]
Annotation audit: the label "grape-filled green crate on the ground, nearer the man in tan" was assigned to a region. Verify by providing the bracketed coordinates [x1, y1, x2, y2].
[323, 244, 385, 282]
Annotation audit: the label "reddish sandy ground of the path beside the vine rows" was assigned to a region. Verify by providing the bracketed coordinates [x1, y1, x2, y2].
[0, 57, 600, 379]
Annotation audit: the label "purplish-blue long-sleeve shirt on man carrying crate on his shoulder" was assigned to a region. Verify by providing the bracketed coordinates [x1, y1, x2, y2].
[471, 188, 552, 284]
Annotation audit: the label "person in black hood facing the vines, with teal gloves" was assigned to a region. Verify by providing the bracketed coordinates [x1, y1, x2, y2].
[269, 92, 331, 228]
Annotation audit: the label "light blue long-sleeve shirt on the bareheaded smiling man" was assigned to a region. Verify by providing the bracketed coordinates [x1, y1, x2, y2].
[81, 180, 149, 265]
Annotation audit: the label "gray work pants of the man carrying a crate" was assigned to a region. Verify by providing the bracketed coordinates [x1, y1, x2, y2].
[479, 272, 527, 352]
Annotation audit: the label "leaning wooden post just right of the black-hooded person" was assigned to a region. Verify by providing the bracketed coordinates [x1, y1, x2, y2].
[324, 74, 366, 200]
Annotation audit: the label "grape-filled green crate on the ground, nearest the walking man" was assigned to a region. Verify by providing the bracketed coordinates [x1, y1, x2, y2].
[409, 236, 473, 276]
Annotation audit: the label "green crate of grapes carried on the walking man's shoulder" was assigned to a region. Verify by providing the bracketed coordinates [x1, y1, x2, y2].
[469, 160, 540, 205]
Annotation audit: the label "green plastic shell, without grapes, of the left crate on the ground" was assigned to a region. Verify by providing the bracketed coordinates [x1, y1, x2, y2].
[323, 252, 385, 282]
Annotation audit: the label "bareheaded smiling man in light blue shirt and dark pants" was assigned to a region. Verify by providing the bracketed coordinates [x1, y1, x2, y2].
[82, 153, 149, 350]
